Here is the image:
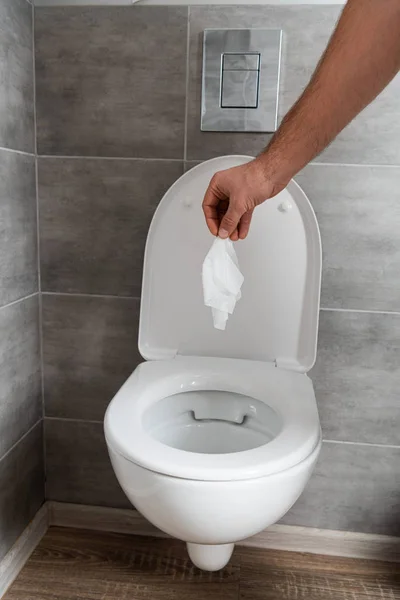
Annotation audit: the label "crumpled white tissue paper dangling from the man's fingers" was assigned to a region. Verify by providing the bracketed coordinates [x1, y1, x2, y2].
[203, 238, 244, 330]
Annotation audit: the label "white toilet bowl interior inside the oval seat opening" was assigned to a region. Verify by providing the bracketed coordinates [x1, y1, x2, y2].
[143, 390, 283, 454]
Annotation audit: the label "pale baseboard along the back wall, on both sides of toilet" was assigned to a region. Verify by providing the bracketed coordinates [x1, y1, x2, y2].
[49, 502, 400, 562]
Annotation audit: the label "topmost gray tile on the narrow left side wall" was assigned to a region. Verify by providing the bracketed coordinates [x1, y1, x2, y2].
[0, 0, 35, 152]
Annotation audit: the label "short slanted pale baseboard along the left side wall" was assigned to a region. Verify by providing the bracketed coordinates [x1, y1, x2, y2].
[0, 503, 49, 598]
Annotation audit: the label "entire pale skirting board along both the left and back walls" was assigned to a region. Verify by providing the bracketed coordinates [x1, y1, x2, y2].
[0, 502, 400, 598]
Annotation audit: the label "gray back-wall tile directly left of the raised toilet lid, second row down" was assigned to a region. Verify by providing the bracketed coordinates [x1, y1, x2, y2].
[39, 158, 183, 296]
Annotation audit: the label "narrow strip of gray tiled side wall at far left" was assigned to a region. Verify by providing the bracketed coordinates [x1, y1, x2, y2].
[0, 0, 44, 560]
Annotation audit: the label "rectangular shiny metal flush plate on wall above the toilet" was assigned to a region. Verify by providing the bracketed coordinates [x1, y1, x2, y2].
[201, 29, 282, 132]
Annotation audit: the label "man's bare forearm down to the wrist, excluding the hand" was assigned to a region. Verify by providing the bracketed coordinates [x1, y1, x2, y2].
[258, 0, 400, 184]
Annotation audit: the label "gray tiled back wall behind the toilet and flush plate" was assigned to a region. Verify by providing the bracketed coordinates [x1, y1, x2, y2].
[36, 5, 400, 535]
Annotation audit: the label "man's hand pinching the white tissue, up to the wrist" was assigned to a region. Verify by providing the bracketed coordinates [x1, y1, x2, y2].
[203, 159, 285, 241]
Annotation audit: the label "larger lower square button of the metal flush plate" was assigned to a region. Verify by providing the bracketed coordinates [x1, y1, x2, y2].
[221, 70, 258, 108]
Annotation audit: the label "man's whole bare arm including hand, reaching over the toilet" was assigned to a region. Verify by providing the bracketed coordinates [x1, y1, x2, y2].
[203, 0, 400, 240]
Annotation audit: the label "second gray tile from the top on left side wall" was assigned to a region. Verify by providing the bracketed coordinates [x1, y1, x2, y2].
[0, 152, 38, 306]
